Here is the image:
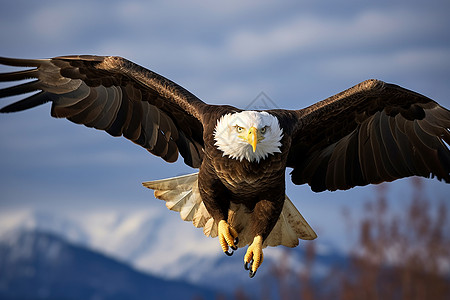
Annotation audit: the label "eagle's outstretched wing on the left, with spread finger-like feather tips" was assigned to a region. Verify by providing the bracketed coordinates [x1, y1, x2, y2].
[0, 56, 206, 167]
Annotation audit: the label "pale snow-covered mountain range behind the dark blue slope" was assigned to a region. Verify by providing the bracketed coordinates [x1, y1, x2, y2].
[0, 206, 346, 291]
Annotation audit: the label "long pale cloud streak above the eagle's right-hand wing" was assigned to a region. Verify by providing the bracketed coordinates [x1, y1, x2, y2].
[226, 9, 441, 61]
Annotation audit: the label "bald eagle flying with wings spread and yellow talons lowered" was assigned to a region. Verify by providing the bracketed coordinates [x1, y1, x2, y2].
[0, 56, 450, 277]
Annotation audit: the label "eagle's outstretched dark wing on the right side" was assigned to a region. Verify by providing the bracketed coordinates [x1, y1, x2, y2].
[288, 80, 450, 192]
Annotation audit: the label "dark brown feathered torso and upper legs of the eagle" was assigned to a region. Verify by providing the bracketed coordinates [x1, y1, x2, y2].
[199, 106, 298, 239]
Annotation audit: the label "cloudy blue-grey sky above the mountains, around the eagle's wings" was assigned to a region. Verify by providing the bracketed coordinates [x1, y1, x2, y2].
[0, 0, 450, 253]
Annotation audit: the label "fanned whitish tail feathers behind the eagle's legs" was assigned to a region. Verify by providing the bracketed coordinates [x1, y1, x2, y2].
[143, 173, 317, 247]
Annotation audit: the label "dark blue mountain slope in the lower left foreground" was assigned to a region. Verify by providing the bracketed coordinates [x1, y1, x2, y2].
[0, 230, 217, 300]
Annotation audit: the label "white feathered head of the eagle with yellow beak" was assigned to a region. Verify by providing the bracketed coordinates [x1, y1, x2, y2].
[214, 111, 283, 162]
